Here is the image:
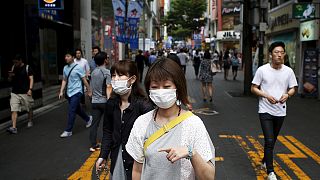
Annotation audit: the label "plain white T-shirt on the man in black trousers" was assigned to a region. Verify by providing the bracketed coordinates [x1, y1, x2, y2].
[252, 63, 298, 116]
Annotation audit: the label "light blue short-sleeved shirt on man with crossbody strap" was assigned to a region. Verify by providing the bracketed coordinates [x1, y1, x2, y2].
[63, 63, 85, 97]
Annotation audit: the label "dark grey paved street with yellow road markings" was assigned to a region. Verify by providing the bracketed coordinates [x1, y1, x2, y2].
[0, 62, 320, 180]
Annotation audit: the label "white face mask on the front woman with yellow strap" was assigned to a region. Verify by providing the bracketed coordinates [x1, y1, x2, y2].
[149, 89, 177, 109]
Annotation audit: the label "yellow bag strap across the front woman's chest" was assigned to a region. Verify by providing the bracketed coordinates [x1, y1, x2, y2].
[143, 111, 193, 152]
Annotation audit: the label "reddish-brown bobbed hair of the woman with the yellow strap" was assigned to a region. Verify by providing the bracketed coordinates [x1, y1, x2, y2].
[144, 58, 190, 105]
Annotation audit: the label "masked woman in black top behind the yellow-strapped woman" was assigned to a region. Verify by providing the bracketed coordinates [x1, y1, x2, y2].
[96, 60, 153, 180]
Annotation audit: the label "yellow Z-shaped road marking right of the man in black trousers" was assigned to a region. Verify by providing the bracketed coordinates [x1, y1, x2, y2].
[277, 136, 310, 180]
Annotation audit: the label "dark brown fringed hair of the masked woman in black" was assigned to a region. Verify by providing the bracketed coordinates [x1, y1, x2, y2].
[110, 60, 146, 98]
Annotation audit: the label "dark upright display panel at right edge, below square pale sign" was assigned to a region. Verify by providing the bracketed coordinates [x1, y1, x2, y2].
[303, 49, 319, 97]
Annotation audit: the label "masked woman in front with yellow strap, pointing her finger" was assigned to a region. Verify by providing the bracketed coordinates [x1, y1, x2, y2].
[126, 59, 215, 180]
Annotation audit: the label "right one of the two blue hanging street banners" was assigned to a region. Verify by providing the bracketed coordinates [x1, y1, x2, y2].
[126, 1, 143, 50]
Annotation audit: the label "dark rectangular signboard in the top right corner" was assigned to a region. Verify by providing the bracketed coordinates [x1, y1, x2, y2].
[292, 3, 316, 19]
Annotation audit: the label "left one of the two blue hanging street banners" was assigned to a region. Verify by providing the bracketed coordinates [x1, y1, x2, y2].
[112, 0, 126, 43]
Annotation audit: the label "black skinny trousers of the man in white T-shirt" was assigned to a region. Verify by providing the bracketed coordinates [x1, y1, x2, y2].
[259, 113, 284, 174]
